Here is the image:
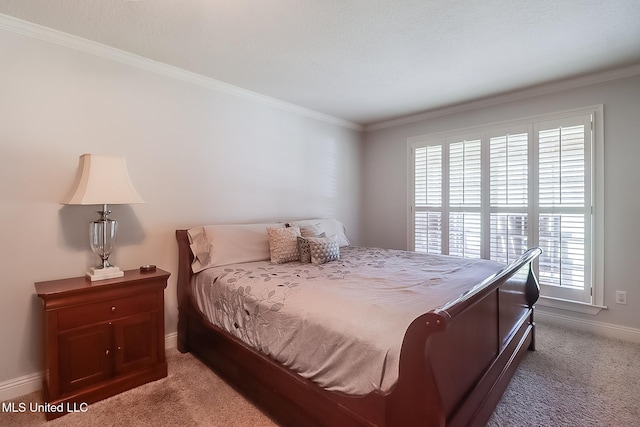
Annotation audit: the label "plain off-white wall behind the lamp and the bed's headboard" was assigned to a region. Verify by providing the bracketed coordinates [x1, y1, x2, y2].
[0, 25, 362, 384]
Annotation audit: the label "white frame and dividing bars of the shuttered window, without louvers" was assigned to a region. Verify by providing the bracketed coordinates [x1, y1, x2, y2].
[407, 105, 606, 314]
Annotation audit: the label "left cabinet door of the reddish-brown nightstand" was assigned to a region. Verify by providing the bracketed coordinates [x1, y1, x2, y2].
[58, 324, 112, 394]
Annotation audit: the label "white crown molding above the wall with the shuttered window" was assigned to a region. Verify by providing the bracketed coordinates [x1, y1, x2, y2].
[364, 64, 640, 132]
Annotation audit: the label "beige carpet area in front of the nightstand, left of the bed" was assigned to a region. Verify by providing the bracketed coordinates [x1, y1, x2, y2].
[0, 349, 276, 427]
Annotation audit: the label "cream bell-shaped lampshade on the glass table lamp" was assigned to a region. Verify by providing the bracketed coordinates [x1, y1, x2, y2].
[62, 154, 144, 205]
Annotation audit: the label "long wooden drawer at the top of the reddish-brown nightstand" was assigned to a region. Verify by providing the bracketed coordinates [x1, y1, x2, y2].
[58, 293, 160, 330]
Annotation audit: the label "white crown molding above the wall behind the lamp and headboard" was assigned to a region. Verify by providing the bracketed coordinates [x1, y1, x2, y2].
[0, 14, 364, 131]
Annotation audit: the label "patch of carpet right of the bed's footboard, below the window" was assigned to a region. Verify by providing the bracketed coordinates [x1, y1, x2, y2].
[489, 324, 640, 427]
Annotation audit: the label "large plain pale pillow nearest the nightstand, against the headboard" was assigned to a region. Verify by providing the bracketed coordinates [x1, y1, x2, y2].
[188, 223, 284, 273]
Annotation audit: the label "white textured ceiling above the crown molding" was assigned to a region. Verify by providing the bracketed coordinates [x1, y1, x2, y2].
[0, 0, 640, 125]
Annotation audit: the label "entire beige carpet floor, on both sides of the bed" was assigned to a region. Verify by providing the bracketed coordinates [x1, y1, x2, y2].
[0, 325, 640, 427]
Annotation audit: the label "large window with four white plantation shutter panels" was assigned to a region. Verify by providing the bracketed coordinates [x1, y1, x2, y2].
[408, 107, 603, 305]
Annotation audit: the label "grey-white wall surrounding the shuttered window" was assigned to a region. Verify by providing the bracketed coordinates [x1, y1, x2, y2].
[362, 75, 640, 336]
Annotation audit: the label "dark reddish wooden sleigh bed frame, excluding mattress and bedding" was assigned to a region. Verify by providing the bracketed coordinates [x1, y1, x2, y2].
[176, 230, 541, 427]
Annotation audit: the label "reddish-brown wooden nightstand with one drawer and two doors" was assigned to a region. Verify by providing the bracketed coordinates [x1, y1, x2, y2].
[35, 269, 170, 419]
